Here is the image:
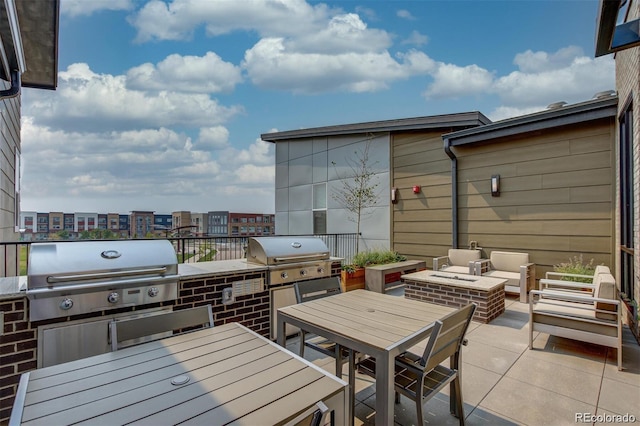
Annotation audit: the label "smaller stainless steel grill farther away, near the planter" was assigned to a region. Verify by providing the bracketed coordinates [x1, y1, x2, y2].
[247, 236, 331, 285]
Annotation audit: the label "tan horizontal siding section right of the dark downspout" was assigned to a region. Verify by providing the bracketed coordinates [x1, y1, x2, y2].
[455, 120, 615, 278]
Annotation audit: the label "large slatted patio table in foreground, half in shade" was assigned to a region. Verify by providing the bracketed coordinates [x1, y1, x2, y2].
[9, 323, 348, 425]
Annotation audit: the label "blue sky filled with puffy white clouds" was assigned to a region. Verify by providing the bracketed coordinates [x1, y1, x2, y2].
[21, 0, 615, 213]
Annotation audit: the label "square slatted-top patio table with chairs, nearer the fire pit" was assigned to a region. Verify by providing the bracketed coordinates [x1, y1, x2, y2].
[277, 290, 455, 425]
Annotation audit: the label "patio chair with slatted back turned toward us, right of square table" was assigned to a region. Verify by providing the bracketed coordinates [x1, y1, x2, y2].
[358, 303, 476, 425]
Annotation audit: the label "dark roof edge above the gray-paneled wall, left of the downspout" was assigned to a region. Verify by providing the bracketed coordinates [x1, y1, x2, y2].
[260, 111, 491, 142]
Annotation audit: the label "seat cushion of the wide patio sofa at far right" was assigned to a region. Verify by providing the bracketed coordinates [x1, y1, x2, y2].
[532, 301, 618, 336]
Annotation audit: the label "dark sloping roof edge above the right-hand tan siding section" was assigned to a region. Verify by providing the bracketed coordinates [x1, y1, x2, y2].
[442, 95, 618, 146]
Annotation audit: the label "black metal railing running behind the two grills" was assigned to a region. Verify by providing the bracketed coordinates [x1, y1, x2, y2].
[0, 233, 358, 277]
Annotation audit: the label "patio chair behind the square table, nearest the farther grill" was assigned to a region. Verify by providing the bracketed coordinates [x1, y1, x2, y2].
[293, 277, 349, 377]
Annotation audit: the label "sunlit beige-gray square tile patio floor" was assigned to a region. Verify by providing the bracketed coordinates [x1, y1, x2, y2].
[287, 288, 640, 426]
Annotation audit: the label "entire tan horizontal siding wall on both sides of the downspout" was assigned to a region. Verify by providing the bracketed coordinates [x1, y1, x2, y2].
[393, 119, 615, 278]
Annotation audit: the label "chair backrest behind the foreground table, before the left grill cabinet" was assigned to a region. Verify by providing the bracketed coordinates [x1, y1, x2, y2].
[109, 305, 213, 351]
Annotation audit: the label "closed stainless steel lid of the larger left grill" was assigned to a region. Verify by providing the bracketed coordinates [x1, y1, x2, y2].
[27, 240, 178, 292]
